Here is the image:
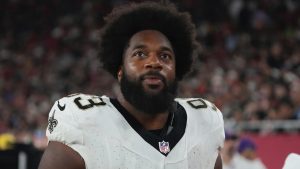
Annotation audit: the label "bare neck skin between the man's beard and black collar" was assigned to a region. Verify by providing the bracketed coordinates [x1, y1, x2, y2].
[117, 94, 169, 130]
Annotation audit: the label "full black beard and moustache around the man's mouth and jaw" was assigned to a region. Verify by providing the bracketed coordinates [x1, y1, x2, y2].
[120, 70, 178, 115]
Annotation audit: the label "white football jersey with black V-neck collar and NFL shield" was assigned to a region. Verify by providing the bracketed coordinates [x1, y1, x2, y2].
[46, 94, 225, 169]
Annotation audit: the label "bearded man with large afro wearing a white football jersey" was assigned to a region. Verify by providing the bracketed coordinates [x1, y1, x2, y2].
[39, 2, 224, 169]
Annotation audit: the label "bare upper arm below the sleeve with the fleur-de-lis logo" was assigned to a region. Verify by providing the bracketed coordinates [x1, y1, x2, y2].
[38, 141, 85, 169]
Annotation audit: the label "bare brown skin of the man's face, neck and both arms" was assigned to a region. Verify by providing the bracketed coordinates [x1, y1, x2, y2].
[39, 30, 222, 169]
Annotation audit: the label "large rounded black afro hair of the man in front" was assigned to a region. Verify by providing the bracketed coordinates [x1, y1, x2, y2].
[99, 2, 197, 80]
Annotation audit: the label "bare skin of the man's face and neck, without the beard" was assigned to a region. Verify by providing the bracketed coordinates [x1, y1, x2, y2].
[117, 30, 175, 130]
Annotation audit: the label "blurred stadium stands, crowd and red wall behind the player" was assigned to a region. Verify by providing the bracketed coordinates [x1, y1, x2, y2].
[0, 0, 300, 169]
